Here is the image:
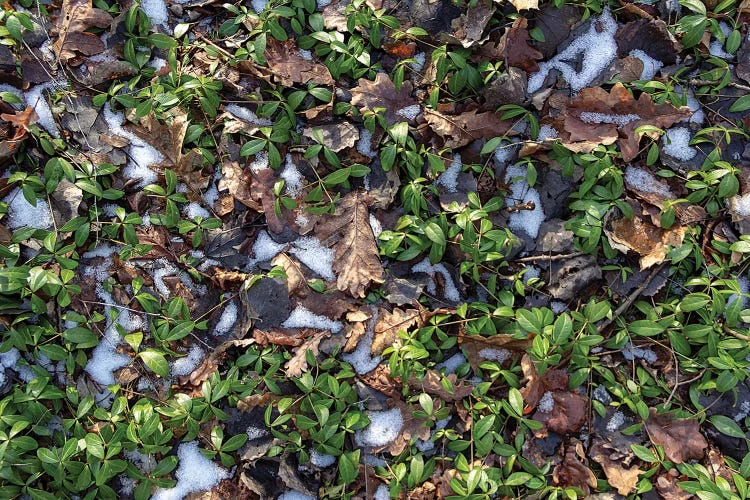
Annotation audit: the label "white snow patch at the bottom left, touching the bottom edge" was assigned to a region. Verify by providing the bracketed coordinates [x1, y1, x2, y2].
[151, 441, 229, 500]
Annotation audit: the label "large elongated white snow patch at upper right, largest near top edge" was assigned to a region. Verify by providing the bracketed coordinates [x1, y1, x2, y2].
[528, 7, 617, 94]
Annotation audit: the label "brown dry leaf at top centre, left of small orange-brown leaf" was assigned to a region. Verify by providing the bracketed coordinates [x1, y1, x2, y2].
[266, 37, 334, 87]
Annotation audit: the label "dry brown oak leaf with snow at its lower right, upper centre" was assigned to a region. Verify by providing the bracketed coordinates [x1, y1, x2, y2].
[351, 73, 417, 126]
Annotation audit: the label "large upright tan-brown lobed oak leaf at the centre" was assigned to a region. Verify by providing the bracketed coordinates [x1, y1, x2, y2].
[315, 191, 383, 297]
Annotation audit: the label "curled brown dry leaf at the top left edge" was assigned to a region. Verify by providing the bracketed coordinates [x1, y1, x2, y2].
[50, 0, 113, 62]
